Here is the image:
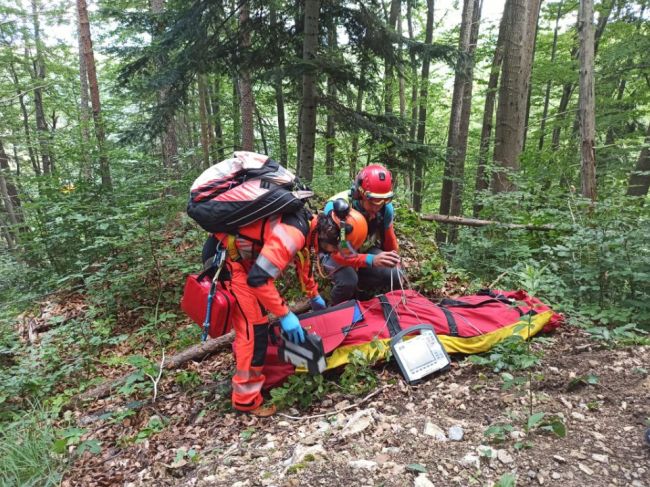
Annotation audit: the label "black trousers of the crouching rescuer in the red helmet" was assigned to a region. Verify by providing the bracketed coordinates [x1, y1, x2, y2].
[320, 247, 402, 305]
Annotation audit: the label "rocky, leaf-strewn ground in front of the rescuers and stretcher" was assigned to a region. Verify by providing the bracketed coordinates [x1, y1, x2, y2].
[63, 327, 650, 487]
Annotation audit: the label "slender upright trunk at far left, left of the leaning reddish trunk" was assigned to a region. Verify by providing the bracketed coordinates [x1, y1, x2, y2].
[32, 0, 54, 174]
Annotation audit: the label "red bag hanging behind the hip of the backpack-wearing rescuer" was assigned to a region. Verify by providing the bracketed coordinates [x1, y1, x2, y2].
[181, 274, 235, 338]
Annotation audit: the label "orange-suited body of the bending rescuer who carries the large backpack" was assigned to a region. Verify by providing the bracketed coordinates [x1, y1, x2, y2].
[203, 209, 325, 416]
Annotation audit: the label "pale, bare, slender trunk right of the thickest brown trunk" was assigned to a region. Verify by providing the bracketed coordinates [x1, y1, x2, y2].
[578, 0, 596, 201]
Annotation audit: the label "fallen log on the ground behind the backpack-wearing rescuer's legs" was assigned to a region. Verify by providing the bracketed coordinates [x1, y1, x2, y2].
[70, 302, 310, 406]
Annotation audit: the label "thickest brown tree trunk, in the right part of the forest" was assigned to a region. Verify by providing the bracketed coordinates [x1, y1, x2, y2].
[492, 0, 540, 193]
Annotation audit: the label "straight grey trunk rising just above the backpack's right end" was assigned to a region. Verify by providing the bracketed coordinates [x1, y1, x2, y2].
[300, 0, 320, 181]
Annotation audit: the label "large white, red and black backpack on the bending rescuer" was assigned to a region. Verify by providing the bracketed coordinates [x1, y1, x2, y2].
[187, 151, 313, 233]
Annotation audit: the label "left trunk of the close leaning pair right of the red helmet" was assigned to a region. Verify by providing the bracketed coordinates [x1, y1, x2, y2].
[438, 0, 476, 222]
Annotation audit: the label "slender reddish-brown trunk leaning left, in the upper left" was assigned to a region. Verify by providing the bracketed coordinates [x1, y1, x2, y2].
[77, 0, 113, 192]
